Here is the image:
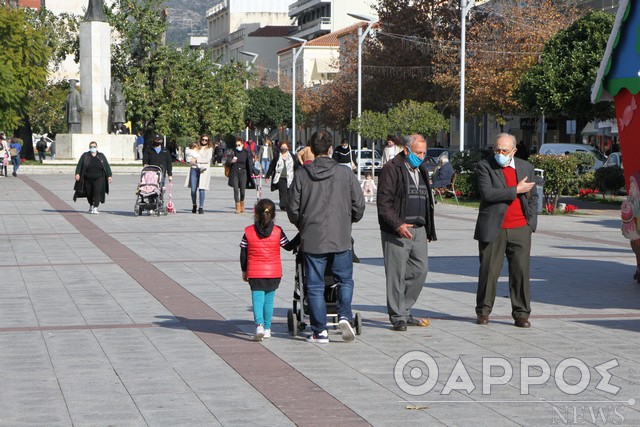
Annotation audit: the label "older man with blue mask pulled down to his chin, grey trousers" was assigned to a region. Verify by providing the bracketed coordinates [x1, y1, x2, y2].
[377, 134, 437, 331]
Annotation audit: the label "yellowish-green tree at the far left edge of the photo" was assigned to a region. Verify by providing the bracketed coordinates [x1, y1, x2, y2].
[0, 7, 51, 133]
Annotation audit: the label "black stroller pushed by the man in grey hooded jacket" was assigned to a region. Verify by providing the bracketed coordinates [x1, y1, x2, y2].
[287, 251, 362, 337]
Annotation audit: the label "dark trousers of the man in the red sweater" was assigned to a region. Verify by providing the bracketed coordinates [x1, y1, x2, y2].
[476, 225, 531, 319]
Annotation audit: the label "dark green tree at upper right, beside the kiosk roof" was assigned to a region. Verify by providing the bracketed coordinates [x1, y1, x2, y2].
[514, 12, 614, 137]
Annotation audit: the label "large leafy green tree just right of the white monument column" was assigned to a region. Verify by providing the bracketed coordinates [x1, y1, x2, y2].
[106, 0, 249, 136]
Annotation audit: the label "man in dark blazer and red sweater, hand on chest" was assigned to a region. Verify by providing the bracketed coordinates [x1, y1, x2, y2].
[474, 133, 538, 328]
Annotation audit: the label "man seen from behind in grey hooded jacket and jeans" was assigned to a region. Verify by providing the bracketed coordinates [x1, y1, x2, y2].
[287, 131, 365, 344]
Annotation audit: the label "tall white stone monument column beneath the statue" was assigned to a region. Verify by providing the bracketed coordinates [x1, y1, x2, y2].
[80, 2, 111, 135]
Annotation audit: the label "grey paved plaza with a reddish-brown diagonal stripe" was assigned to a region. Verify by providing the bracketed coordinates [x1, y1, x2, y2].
[0, 167, 640, 427]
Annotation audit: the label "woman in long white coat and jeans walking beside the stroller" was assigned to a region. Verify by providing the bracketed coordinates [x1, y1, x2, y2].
[184, 134, 213, 214]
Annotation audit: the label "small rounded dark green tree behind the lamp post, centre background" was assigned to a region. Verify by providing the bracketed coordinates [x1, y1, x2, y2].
[244, 86, 300, 138]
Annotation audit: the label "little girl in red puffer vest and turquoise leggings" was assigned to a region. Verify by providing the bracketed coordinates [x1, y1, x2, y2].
[240, 199, 296, 341]
